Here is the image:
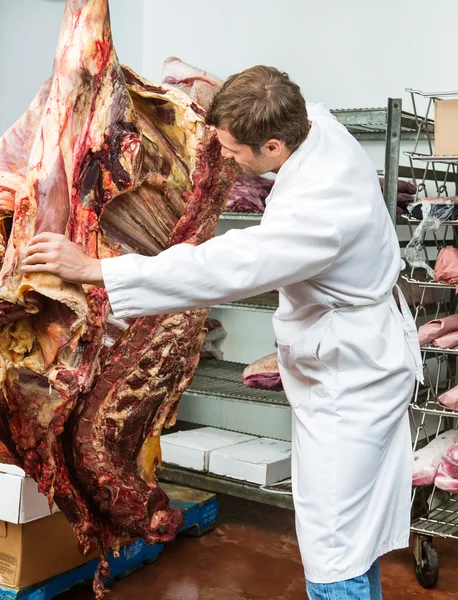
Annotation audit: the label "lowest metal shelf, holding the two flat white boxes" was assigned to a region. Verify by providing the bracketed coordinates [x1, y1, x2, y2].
[159, 464, 294, 510]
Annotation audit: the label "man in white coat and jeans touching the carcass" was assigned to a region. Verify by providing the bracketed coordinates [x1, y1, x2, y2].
[23, 66, 421, 600]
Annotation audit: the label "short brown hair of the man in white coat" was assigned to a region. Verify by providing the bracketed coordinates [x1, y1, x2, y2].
[206, 65, 309, 152]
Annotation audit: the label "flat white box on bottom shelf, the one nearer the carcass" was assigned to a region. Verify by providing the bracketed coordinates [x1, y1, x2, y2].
[161, 427, 256, 471]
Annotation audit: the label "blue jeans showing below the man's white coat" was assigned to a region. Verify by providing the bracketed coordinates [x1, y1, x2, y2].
[307, 560, 383, 600]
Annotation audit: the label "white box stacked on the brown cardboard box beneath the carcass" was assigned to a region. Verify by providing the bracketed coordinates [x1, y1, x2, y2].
[0, 467, 59, 524]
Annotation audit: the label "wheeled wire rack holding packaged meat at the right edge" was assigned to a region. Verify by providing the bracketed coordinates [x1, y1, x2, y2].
[404, 90, 458, 588]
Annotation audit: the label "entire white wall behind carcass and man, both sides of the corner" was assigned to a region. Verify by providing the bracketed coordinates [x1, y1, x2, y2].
[0, 0, 458, 162]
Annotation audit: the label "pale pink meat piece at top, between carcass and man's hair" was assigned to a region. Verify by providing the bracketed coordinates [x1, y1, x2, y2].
[162, 56, 223, 110]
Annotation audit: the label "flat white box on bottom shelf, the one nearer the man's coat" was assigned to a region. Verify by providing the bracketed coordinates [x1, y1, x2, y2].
[209, 438, 291, 485]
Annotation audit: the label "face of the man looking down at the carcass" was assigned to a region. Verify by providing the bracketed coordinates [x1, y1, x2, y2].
[216, 128, 275, 177]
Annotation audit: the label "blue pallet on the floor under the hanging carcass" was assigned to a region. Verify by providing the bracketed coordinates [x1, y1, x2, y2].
[0, 484, 218, 600]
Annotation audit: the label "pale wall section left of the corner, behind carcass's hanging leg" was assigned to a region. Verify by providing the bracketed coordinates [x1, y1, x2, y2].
[0, 0, 145, 135]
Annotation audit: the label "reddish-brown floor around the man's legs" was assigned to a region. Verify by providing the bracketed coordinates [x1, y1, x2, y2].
[59, 497, 458, 600]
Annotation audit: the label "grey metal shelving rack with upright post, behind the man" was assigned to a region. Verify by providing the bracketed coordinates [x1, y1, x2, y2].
[160, 98, 434, 509]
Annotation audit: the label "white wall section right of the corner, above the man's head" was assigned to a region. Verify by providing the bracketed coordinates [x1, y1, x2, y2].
[145, 0, 458, 108]
